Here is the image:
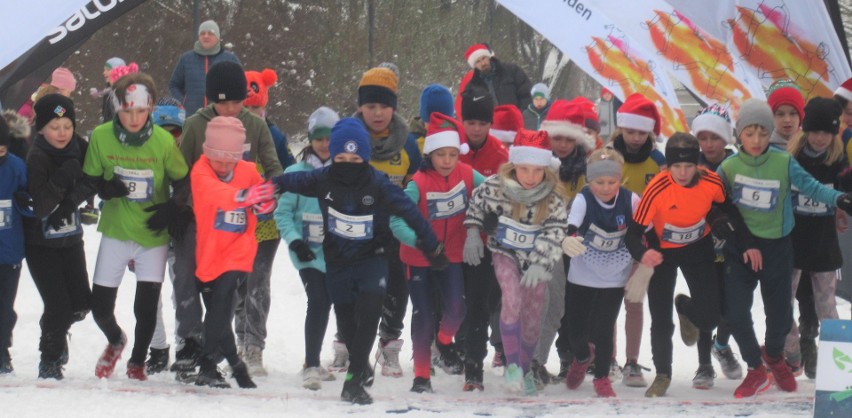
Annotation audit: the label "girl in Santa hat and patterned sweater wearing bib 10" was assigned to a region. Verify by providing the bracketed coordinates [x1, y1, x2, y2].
[464, 131, 568, 394]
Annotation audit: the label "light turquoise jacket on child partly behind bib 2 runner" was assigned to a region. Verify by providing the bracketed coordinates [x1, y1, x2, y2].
[275, 161, 325, 273]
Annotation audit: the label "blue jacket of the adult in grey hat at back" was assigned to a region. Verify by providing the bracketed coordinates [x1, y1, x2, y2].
[169, 48, 242, 116]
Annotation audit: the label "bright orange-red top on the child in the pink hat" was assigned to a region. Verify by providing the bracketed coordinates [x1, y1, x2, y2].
[190, 155, 263, 283]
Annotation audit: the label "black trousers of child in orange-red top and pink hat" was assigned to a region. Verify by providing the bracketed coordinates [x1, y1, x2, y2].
[196, 271, 243, 366]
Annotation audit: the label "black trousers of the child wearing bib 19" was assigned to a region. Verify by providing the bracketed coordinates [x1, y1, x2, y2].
[563, 282, 624, 379]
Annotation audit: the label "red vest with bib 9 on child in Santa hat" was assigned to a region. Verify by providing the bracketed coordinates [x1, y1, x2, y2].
[399, 162, 473, 267]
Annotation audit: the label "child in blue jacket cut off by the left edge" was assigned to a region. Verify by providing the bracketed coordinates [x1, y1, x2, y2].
[0, 118, 32, 376]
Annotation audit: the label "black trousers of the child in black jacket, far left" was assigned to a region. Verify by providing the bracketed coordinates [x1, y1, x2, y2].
[25, 242, 92, 362]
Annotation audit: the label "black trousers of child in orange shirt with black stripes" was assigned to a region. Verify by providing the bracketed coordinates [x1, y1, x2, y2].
[648, 235, 721, 376]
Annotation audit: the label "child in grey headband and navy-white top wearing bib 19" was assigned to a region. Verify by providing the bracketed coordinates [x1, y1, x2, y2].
[562, 148, 639, 398]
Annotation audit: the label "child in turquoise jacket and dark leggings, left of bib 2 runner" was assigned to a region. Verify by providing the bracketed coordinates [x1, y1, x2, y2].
[275, 106, 340, 390]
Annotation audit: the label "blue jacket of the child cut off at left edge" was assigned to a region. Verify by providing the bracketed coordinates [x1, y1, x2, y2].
[0, 154, 32, 265]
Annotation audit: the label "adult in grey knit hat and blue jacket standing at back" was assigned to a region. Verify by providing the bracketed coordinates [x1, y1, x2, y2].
[169, 20, 240, 115]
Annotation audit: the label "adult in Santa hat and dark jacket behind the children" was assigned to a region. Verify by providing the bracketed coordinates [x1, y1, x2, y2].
[459, 44, 532, 111]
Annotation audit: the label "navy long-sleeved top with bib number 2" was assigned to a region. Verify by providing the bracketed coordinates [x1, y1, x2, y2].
[272, 164, 438, 266]
